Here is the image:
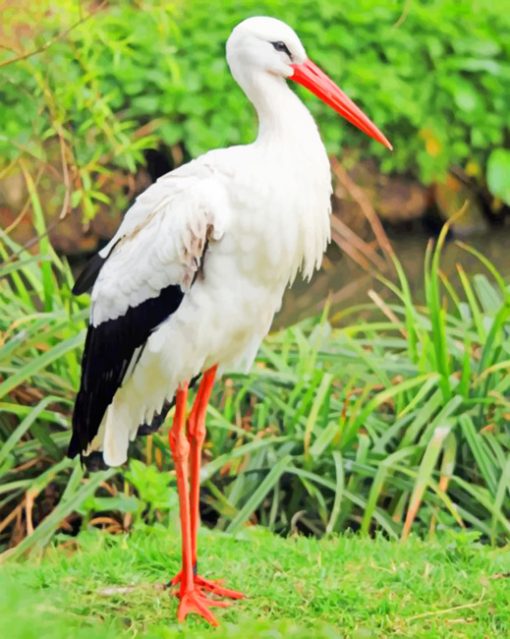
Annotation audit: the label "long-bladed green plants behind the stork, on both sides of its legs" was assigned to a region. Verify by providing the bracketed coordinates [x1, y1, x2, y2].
[0, 211, 510, 556]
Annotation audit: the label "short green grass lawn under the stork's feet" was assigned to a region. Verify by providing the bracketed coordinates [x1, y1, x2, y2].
[0, 528, 510, 639]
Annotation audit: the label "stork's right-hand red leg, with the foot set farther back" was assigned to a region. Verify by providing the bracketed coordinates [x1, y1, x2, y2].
[171, 365, 244, 599]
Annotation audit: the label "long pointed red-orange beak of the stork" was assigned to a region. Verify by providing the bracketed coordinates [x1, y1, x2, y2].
[289, 60, 393, 151]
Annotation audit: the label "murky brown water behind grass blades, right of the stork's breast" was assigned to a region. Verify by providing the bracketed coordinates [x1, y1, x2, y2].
[275, 228, 510, 327]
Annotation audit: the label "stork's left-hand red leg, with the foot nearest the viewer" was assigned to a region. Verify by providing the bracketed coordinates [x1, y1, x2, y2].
[168, 384, 226, 626]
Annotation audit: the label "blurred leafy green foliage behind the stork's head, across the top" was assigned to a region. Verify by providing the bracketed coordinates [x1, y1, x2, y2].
[0, 0, 510, 217]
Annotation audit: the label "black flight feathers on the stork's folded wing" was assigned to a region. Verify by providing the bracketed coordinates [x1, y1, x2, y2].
[68, 284, 184, 457]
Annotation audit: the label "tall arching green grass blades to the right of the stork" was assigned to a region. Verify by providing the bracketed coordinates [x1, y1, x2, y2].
[206, 227, 510, 542]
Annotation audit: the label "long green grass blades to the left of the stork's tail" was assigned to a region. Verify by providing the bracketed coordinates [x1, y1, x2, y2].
[0, 180, 113, 554]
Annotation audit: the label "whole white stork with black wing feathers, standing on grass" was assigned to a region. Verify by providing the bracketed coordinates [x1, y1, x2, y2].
[69, 17, 391, 625]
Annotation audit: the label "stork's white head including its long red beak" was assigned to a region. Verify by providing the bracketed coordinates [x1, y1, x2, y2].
[227, 17, 393, 150]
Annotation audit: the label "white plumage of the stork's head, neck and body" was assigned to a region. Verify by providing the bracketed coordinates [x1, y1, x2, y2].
[71, 18, 388, 466]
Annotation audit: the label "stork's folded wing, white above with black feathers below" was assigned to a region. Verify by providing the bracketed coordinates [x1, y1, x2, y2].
[68, 162, 226, 457]
